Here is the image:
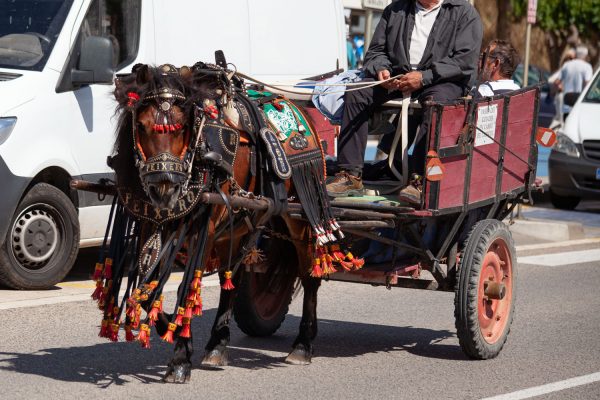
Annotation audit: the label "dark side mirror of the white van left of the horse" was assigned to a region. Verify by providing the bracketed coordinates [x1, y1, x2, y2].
[71, 36, 115, 86]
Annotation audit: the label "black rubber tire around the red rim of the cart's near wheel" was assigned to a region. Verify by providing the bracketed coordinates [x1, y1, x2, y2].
[454, 219, 517, 360]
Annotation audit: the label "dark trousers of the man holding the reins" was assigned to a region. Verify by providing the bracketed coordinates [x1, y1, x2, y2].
[337, 78, 466, 176]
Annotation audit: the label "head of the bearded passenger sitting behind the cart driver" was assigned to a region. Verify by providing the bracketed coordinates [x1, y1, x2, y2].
[480, 39, 521, 81]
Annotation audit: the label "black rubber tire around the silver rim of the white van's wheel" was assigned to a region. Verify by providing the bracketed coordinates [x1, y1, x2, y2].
[0, 183, 79, 290]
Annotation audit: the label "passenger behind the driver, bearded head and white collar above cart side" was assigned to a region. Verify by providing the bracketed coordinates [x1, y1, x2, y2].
[471, 39, 520, 99]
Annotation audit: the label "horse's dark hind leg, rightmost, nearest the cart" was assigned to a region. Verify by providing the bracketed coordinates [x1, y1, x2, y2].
[285, 275, 321, 365]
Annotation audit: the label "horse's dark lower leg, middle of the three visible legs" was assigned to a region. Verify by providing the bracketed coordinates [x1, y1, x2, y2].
[201, 273, 241, 368]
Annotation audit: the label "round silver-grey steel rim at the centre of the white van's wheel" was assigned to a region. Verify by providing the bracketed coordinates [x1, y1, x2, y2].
[12, 209, 59, 267]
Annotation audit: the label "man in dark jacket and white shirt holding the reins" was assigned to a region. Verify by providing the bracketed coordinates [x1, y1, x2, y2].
[327, 0, 483, 203]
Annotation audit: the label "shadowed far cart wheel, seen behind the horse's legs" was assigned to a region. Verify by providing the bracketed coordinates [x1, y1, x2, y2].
[233, 231, 298, 336]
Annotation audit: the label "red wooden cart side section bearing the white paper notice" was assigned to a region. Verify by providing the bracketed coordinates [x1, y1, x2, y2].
[468, 99, 504, 204]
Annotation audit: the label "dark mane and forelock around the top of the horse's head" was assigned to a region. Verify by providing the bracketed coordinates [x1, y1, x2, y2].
[109, 63, 222, 196]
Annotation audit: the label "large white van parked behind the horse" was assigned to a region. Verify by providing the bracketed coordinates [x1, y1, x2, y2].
[0, 0, 346, 289]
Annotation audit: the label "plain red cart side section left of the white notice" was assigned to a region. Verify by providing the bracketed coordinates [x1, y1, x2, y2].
[425, 105, 467, 209]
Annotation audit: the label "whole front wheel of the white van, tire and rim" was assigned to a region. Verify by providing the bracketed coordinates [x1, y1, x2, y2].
[0, 183, 79, 289]
